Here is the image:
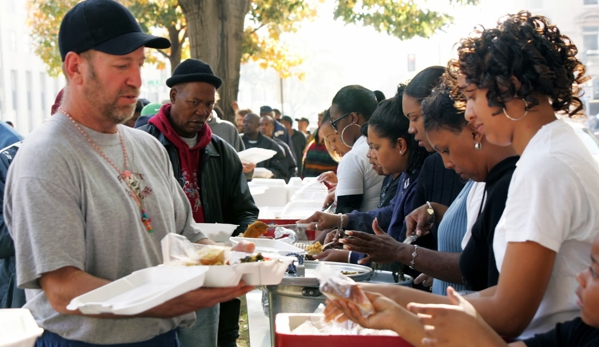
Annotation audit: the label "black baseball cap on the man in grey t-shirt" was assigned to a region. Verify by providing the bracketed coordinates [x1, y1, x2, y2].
[58, 0, 171, 61]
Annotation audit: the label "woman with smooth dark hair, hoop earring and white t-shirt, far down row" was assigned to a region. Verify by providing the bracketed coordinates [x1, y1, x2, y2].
[330, 85, 383, 213]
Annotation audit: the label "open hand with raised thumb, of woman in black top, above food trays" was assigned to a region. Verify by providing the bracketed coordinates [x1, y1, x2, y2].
[339, 218, 402, 264]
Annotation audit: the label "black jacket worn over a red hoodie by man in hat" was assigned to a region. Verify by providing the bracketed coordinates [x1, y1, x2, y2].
[139, 124, 259, 236]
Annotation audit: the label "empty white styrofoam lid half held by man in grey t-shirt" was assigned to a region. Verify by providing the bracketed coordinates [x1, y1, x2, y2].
[67, 266, 208, 315]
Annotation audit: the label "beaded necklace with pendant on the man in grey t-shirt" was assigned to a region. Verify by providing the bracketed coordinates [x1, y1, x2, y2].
[58, 107, 154, 233]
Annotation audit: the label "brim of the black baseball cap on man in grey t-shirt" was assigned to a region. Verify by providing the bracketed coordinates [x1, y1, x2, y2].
[93, 32, 171, 55]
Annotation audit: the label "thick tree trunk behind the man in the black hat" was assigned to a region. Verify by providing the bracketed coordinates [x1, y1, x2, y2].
[179, 0, 251, 124]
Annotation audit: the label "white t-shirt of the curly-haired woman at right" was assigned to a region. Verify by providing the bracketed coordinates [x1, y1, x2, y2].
[493, 120, 599, 338]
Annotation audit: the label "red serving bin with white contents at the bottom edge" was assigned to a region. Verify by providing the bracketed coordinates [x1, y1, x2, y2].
[275, 313, 413, 347]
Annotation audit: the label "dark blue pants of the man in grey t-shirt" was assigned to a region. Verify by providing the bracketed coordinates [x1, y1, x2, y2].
[35, 330, 180, 347]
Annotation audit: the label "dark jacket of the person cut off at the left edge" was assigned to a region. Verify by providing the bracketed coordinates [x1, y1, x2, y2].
[0, 142, 25, 308]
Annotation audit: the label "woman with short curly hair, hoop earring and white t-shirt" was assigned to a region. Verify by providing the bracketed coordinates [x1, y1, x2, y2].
[328, 11, 599, 346]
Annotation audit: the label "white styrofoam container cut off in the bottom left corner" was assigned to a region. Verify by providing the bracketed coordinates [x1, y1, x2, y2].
[0, 308, 44, 347]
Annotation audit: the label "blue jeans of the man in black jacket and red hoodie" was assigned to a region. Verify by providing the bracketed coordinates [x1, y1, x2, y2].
[177, 305, 220, 347]
